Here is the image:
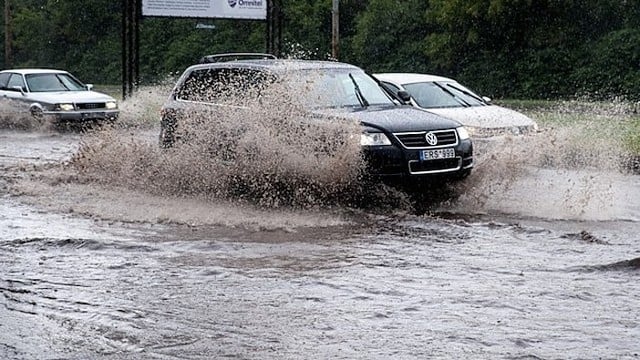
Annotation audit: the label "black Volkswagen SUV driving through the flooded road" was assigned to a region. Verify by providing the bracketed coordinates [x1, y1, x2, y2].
[160, 54, 473, 184]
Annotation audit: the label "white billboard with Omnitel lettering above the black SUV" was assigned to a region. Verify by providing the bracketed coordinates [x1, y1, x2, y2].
[142, 0, 267, 20]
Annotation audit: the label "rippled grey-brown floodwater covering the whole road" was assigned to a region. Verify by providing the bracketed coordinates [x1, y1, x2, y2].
[0, 105, 640, 359]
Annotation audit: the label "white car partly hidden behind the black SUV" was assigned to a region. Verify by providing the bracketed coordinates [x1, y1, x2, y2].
[374, 73, 538, 138]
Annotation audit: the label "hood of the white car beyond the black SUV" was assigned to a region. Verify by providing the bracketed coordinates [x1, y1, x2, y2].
[425, 105, 536, 130]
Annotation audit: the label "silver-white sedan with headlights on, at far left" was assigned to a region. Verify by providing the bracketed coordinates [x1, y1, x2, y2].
[0, 69, 119, 123]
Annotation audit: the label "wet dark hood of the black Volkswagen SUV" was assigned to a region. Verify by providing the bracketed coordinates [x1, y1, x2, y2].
[314, 106, 461, 132]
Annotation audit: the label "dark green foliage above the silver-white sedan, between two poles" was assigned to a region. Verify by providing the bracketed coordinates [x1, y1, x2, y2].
[12, 0, 121, 82]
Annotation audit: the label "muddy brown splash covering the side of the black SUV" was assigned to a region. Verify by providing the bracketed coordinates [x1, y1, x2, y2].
[70, 78, 390, 207]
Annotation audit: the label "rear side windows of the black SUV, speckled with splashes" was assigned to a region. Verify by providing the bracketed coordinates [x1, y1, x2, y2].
[176, 68, 275, 105]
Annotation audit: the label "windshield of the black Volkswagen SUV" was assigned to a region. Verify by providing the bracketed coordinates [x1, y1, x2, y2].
[287, 69, 393, 108]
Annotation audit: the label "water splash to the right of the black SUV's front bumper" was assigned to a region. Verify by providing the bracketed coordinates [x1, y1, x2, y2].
[456, 102, 640, 220]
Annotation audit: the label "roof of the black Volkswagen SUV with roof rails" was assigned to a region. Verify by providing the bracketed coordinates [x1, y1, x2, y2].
[189, 59, 361, 72]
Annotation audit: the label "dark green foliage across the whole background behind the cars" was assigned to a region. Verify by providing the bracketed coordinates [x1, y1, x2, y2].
[0, 0, 640, 99]
